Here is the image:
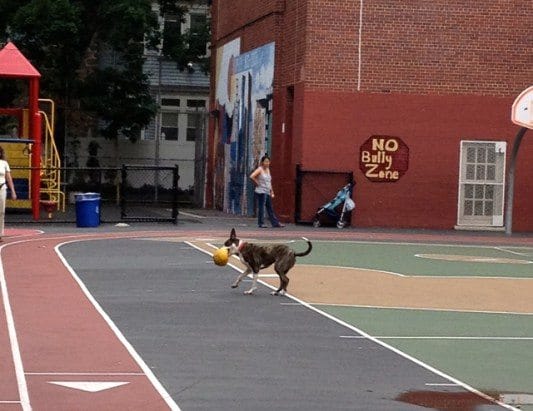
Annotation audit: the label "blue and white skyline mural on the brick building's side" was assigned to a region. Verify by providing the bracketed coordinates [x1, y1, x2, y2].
[215, 40, 275, 215]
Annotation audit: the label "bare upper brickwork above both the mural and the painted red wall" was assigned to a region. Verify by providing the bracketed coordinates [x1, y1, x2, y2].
[212, 0, 533, 93]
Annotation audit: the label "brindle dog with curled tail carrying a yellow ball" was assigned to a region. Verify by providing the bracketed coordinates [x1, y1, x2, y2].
[224, 228, 313, 295]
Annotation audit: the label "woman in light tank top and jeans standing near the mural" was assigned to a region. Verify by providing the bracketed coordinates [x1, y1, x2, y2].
[250, 155, 285, 228]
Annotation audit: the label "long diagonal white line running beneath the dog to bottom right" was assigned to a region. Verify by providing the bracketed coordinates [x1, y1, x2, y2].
[185, 241, 520, 411]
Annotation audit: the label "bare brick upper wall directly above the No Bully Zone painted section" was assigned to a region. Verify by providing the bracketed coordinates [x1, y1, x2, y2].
[305, 0, 533, 96]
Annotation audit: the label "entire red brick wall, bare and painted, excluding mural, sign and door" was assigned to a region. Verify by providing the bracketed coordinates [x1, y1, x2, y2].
[209, 0, 533, 231]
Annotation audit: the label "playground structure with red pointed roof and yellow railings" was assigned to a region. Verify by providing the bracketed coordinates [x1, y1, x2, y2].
[0, 42, 65, 220]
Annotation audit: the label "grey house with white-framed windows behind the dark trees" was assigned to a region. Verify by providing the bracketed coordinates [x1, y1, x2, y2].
[77, 0, 209, 195]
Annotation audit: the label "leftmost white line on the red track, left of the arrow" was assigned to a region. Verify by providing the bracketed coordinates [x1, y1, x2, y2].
[0, 244, 31, 411]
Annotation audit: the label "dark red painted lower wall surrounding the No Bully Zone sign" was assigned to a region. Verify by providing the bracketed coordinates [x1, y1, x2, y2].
[277, 91, 533, 231]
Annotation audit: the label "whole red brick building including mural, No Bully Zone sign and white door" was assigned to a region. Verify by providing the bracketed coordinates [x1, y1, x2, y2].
[206, 0, 533, 231]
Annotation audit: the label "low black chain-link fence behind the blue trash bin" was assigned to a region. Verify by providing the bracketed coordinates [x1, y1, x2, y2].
[6, 165, 187, 224]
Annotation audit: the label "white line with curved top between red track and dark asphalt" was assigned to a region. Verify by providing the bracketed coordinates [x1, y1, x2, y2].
[54, 239, 180, 411]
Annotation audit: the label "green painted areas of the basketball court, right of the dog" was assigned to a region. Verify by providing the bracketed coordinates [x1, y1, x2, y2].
[282, 241, 533, 410]
